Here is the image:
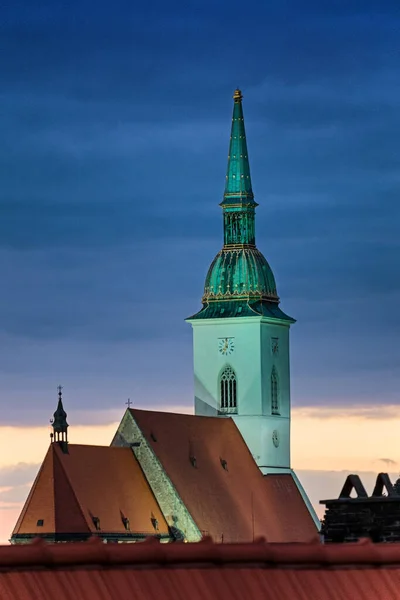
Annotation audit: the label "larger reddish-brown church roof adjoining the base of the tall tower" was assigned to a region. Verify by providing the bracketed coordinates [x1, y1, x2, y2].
[130, 409, 317, 542]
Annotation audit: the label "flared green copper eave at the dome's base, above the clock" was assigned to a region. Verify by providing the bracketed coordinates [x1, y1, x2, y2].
[186, 300, 296, 324]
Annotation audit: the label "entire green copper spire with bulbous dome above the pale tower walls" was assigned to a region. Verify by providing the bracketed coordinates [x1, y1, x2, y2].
[189, 90, 293, 321]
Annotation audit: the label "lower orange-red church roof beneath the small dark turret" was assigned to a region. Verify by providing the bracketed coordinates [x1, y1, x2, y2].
[13, 443, 168, 535]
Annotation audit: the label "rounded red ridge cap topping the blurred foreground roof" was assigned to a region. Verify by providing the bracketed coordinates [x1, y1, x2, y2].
[0, 537, 400, 570]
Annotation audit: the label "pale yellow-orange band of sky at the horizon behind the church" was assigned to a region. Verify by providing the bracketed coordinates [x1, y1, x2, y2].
[0, 406, 400, 543]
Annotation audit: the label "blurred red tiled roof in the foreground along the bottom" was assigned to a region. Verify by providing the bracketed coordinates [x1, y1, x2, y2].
[0, 540, 400, 600]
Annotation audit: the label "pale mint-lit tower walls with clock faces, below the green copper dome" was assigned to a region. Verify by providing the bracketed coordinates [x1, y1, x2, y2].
[189, 317, 290, 473]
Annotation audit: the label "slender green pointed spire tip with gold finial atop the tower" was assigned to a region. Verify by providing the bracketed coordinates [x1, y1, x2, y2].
[221, 90, 256, 205]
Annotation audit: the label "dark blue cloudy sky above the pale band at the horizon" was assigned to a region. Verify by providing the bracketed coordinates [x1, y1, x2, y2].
[0, 0, 400, 424]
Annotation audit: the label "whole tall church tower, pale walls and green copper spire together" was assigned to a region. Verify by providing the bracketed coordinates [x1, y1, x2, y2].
[187, 90, 294, 474]
